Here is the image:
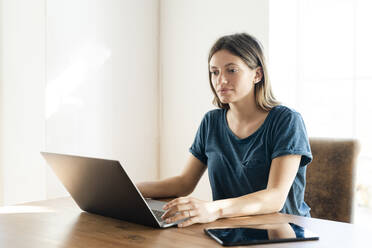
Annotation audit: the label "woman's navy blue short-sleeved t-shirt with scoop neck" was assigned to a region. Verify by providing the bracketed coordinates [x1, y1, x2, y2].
[190, 105, 312, 216]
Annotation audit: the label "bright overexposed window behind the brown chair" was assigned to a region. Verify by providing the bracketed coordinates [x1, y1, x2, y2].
[268, 0, 372, 222]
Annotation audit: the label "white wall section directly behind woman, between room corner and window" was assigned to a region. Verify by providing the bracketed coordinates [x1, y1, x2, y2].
[160, 0, 268, 199]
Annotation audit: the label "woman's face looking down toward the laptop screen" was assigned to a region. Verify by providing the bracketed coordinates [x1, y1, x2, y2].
[209, 50, 261, 103]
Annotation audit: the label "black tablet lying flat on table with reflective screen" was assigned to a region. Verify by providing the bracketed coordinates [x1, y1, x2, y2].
[204, 223, 319, 246]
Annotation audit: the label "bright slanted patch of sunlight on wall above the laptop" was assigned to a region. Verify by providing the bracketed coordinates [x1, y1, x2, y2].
[45, 44, 111, 120]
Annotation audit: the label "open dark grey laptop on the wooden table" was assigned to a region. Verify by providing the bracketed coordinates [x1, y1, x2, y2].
[41, 152, 182, 228]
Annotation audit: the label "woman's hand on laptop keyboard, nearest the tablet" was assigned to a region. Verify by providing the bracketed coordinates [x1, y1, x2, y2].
[162, 197, 220, 227]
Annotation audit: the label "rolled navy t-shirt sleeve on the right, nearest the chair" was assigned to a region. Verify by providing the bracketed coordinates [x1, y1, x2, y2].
[271, 111, 313, 166]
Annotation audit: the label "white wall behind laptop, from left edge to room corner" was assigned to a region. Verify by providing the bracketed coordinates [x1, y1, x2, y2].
[0, 0, 159, 205]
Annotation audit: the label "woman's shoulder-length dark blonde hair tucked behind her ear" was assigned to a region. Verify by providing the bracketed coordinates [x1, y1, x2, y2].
[208, 33, 280, 111]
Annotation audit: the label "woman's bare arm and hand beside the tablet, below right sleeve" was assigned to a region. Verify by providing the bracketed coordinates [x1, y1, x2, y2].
[164, 155, 301, 227]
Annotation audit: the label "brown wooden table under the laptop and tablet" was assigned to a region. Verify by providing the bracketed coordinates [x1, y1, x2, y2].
[0, 197, 372, 248]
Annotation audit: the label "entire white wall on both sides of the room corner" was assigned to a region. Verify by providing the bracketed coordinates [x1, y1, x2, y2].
[0, 0, 268, 205]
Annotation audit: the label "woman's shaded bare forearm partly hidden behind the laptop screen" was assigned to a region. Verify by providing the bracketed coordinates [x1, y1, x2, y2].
[137, 155, 207, 198]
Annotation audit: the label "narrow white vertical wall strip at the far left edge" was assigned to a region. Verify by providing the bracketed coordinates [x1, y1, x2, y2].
[0, 0, 45, 204]
